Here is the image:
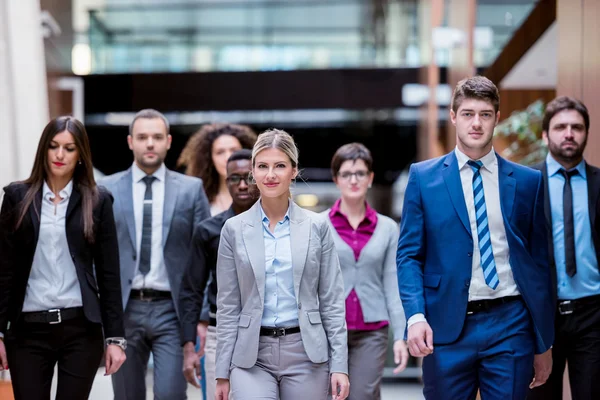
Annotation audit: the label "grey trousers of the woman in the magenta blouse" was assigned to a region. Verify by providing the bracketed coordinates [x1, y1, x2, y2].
[348, 326, 388, 400]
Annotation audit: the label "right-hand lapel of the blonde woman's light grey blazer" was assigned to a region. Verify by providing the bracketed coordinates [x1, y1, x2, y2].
[290, 200, 311, 298]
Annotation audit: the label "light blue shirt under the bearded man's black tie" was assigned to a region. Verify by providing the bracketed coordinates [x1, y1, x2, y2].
[546, 154, 600, 300]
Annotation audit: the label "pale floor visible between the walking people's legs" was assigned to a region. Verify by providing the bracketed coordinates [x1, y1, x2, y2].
[82, 368, 423, 400]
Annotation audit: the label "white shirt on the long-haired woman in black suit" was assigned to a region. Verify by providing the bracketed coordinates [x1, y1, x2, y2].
[23, 181, 83, 312]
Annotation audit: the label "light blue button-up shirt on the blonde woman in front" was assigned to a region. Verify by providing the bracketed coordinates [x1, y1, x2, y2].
[260, 203, 298, 328]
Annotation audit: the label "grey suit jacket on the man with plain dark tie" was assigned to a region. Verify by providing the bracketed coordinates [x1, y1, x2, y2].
[99, 168, 210, 315]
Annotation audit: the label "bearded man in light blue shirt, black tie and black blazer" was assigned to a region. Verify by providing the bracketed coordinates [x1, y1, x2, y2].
[528, 97, 600, 400]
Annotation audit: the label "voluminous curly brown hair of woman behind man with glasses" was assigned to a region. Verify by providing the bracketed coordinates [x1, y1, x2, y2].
[177, 123, 256, 203]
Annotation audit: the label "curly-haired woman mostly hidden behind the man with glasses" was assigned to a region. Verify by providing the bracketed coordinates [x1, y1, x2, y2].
[177, 123, 256, 215]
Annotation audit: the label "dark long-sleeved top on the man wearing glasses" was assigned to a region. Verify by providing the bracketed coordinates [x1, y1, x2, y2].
[179, 208, 235, 344]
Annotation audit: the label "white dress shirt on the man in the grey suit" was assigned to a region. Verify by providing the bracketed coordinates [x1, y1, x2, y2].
[131, 163, 171, 292]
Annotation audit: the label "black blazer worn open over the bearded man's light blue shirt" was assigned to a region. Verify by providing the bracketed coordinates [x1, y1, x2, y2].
[532, 161, 600, 300]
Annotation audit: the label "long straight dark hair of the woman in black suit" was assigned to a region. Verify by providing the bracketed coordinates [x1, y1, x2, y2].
[15, 116, 98, 243]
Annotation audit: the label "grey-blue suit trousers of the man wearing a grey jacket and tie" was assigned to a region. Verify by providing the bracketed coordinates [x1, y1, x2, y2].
[112, 300, 187, 400]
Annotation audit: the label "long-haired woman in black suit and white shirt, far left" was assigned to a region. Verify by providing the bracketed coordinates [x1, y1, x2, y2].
[0, 117, 126, 400]
